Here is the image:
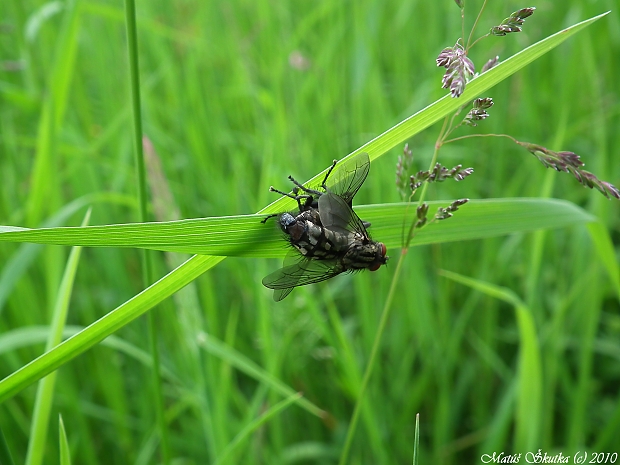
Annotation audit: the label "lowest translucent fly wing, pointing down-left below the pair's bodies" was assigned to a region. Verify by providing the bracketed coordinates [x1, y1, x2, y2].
[263, 250, 344, 302]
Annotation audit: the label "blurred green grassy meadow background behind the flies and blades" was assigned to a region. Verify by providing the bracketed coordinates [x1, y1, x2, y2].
[0, 0, 620, 464]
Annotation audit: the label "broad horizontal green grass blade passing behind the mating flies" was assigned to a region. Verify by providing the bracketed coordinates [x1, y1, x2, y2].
[0, 199, 594, 257]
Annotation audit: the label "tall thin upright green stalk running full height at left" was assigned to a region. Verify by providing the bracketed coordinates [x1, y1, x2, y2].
[125, 0, 170, 465]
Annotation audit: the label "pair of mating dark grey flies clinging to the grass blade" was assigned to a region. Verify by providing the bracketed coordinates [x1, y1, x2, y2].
[262, 152, 388, 302]
